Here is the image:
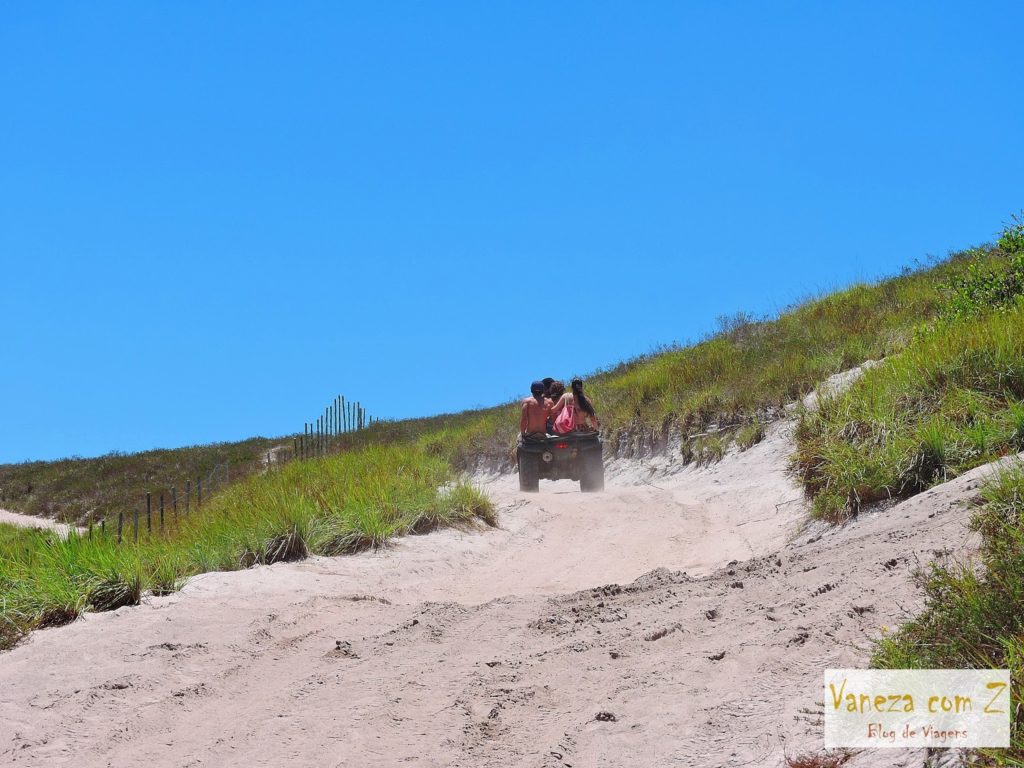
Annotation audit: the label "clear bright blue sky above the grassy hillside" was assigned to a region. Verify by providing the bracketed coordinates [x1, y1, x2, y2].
[0, 2, 1024, 462]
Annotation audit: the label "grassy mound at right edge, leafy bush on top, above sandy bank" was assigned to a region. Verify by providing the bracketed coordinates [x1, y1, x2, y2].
[797, 225, 1024, 520]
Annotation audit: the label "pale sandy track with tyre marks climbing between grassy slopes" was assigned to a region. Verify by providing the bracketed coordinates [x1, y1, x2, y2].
[0, 411, 991, 768]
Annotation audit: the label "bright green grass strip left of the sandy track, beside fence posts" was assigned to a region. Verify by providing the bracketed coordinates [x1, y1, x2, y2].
[0, 445, 494, 648]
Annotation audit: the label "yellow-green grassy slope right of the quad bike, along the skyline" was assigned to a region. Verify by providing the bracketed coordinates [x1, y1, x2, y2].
[594, 264, 950, 434]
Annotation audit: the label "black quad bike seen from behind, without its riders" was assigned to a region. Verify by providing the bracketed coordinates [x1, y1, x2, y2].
[515, 432, 604, 493]
